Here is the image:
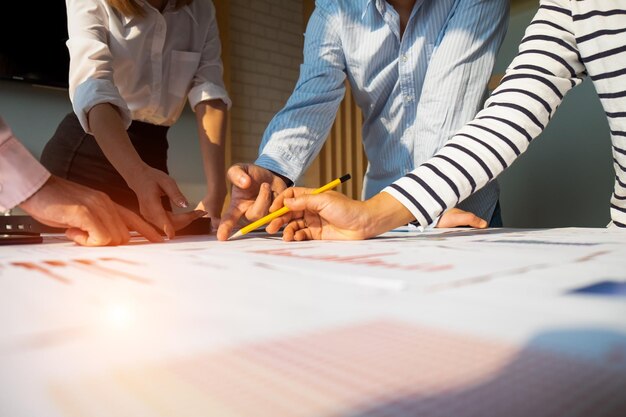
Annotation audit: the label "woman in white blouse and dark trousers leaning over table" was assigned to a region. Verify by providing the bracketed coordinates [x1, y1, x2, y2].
[41, 0, 231, 238]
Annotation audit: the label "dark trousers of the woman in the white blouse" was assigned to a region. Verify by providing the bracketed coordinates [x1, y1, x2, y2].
[41, 113, 171, 213]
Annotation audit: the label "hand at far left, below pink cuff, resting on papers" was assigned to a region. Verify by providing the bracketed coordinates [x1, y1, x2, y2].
[20, 176, 163, 246]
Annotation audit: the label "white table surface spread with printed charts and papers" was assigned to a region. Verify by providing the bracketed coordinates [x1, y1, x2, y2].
[0, 228, 626, 417]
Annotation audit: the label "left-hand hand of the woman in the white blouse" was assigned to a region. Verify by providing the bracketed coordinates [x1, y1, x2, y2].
[127, 165, 188, 239]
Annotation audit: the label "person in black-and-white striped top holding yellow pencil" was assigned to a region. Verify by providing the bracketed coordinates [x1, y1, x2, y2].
[267, 0, 626, 240]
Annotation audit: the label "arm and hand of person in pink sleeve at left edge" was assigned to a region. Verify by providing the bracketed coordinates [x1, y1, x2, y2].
[0, 117, 202, 246]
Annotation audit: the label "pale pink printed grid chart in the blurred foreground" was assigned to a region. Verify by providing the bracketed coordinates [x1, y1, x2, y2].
[52, 321, 626, 417]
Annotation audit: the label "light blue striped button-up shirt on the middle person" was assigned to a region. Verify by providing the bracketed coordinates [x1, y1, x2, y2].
[255, 0, 509, 220]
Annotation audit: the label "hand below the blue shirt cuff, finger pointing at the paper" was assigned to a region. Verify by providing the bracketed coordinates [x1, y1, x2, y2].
[217, 164, 287, 240]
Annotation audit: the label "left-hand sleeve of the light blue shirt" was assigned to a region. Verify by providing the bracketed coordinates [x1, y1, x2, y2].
[255, 4, 346, 182]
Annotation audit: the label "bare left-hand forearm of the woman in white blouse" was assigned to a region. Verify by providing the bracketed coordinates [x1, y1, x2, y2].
[88, 103, 145, 182]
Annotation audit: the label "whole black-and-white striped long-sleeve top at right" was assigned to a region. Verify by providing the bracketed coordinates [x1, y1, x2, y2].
[384, 0, 626, 227]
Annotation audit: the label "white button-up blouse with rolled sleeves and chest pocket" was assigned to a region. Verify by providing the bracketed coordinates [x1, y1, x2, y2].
[66, 0, 231, 132]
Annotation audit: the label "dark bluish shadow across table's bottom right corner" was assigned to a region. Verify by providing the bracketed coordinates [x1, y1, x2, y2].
[341, 329, 626, 417]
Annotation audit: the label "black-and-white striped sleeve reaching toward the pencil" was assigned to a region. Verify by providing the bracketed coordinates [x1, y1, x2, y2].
[383, 0, 586, 226]
